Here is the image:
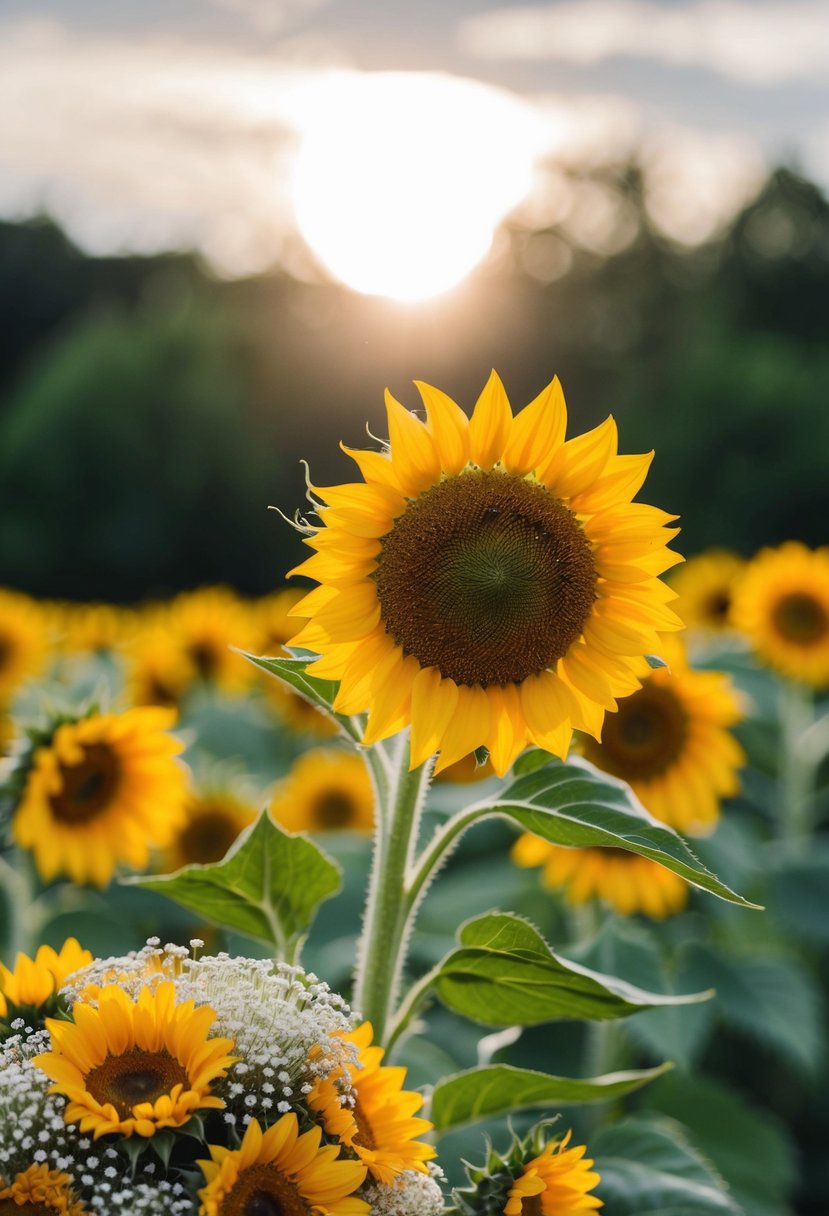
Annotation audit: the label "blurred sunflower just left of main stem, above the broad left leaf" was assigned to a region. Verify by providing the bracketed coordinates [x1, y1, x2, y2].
[271, 748, 374, 832]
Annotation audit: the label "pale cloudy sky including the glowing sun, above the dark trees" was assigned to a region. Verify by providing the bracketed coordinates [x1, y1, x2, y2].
[0, 0, 829, 299]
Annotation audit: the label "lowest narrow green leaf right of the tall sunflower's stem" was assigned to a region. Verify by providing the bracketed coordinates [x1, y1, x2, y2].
[430, 1064, 671, 1132]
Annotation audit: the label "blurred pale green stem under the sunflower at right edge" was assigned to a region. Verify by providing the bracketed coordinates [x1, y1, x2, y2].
[779, 680, 814, 852]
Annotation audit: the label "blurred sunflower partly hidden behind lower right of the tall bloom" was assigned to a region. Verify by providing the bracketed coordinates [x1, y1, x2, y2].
[573, 637, 745, 835]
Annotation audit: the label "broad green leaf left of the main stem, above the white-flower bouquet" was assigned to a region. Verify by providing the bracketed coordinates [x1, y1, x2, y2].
[124, 811, 342, 958]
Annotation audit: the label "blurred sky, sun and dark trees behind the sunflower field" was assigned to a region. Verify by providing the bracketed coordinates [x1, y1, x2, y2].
[0, 0, 829, 602]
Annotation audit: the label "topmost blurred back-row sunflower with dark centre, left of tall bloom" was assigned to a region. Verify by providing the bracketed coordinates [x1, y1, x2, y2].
[168, 587, 252, 693]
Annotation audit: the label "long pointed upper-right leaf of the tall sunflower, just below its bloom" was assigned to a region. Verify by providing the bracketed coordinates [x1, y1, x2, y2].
[480, 758, 758, 908]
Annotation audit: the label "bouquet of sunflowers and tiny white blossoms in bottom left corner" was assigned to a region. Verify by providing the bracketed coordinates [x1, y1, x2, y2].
[0, 939, 442, 1216]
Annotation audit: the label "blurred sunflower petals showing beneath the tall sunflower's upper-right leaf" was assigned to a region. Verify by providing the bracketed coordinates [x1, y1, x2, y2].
[512, 832, 688, 921]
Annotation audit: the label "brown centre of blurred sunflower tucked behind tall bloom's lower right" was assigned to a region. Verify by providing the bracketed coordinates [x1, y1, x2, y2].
[586, 681, 688, 781]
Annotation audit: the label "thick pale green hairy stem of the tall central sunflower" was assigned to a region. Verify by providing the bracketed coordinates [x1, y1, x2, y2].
[354, 734, 432, 1046]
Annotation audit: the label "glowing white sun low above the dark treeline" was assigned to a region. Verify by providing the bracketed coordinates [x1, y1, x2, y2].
[293, 72, 541, 302]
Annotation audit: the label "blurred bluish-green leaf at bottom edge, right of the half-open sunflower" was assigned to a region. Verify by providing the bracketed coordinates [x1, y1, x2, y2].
[590, 1116, 744, 1216]
